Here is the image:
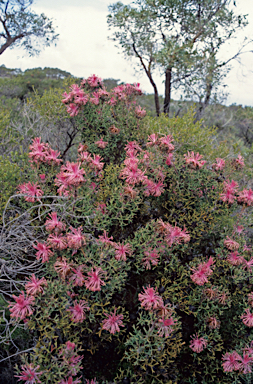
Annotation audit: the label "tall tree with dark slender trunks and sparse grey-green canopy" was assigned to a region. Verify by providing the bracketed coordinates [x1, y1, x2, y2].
[107, 0, 247, 115]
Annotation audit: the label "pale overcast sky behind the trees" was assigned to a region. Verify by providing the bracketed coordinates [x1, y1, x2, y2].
[0, 0, 253, 106]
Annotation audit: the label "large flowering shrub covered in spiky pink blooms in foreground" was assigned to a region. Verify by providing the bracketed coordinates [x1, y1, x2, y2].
[4, 75, 253, 384]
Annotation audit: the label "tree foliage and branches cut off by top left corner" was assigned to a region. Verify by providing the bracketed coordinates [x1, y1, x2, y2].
[0, 0, 58, 56]
